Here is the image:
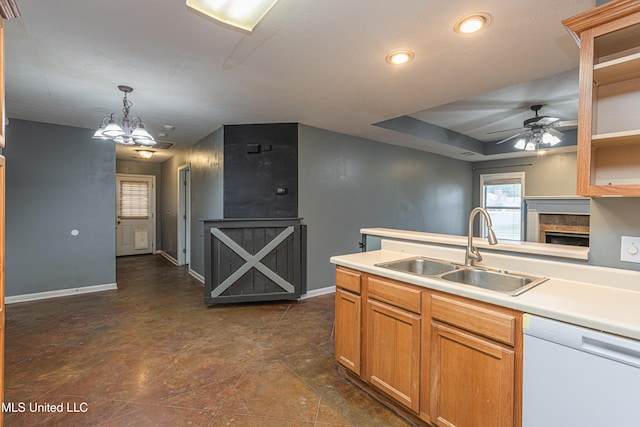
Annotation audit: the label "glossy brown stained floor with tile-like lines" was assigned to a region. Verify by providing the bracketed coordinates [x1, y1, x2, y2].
[4, 255, 407, 427]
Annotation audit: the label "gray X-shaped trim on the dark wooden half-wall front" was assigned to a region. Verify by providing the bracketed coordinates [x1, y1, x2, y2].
[211, 226, 295, 298]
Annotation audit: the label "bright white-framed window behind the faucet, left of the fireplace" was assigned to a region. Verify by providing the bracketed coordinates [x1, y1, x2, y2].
[480, 172, 524, 240]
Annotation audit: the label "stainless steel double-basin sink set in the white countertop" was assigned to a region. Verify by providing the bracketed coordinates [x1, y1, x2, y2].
[376, 257, 547, 296]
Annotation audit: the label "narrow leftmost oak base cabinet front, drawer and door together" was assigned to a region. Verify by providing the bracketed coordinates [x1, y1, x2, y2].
[335, 267, 362, 376]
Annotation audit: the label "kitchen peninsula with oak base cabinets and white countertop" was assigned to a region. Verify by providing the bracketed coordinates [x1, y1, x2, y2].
[331, 229, 640, 426]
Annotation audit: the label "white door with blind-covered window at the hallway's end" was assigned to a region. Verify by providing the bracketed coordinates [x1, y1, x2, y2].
[116, 174, 155, 256]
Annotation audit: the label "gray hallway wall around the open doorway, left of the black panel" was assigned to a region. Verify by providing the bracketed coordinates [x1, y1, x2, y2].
[160, 128, 224, 275]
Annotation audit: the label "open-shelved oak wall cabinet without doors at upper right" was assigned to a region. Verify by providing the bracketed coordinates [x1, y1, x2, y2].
[562, 0, 640, 197]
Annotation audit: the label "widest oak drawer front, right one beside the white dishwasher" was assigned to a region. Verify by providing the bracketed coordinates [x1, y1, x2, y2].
[431, 294, 517, 346]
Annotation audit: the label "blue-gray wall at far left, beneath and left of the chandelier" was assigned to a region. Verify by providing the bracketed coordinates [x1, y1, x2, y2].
[4, 119, 116, 296]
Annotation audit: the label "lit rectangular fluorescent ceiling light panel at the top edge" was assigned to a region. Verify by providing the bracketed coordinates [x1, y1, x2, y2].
[186, 0, 278, 33]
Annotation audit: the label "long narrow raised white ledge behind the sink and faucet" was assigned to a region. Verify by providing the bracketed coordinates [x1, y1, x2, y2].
[360, 228, 589, 261]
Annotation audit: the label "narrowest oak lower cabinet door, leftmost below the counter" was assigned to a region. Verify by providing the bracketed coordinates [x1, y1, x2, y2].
[335, 288, 362, 376]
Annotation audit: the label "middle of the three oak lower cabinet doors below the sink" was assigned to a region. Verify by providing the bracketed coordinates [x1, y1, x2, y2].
[366, 300, 420, 413]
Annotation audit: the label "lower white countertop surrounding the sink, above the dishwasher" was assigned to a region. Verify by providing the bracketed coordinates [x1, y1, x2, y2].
[331, 241, 640, 339]
